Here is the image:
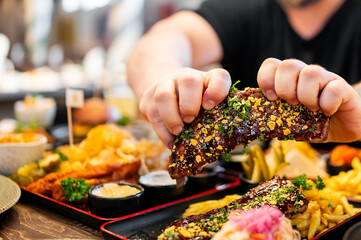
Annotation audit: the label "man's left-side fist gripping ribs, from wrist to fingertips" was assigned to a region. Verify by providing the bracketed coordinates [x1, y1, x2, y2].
[139, 68, 231, 148]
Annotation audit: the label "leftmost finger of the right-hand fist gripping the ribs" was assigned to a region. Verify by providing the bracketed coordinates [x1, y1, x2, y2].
[257, 58, 281, 101]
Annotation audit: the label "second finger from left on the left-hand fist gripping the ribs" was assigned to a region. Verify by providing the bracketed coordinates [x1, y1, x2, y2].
[154, 78, 183, 135]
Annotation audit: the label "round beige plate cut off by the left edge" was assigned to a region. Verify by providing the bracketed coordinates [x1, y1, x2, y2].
[0, 175, 21, 214]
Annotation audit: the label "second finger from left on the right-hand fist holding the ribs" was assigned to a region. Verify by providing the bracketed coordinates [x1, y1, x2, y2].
[274, 59, 307, 105]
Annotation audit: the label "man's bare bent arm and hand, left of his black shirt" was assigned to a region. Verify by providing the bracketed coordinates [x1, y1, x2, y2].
[127, 12, 231, 146]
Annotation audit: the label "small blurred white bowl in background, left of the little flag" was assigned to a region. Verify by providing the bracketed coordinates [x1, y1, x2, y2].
[14, 98, 56, 127]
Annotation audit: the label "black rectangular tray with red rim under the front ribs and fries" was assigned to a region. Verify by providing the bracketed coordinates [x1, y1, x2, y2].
[100, 188, 361, 240]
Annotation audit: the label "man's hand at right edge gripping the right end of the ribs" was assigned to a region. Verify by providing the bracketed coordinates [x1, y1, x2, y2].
[257, 58, 361, 142]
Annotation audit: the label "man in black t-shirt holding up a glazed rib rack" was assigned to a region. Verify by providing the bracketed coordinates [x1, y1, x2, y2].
[127, 0, 361, 147]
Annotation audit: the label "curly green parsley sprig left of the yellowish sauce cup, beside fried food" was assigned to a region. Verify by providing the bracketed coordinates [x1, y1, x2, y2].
[61, 178, 91, 202]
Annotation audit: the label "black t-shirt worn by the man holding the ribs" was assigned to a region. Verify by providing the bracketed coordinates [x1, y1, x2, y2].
[196, 0, 361, 88]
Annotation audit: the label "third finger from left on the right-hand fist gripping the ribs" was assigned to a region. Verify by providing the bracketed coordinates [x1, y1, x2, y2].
[297, 65, 339, 111]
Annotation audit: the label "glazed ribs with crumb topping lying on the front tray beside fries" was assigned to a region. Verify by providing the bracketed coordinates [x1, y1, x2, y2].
[158, 176, 308, 240]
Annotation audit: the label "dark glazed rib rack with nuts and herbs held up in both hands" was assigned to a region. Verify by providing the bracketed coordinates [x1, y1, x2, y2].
[168, 88, 329, 179]
